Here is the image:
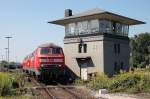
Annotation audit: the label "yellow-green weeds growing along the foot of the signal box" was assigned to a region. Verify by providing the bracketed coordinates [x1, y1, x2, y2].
[75, 69, 150, 93]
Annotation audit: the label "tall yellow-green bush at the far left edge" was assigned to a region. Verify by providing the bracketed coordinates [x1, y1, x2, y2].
[0, 72, 12, 96]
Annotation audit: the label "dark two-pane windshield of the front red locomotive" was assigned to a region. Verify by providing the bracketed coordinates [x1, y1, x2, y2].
[40, 48, 62, 54]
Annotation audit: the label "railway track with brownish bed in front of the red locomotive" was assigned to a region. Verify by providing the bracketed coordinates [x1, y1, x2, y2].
[27, 77, 95, 99]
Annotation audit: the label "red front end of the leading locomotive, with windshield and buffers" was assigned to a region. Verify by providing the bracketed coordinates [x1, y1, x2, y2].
[39, 46, 65, 79]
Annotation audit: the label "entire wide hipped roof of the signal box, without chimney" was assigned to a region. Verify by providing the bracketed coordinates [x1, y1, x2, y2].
[48, 8, 145, 26]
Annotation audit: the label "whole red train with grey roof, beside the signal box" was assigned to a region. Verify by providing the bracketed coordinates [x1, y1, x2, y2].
[22, 43, 65, 79]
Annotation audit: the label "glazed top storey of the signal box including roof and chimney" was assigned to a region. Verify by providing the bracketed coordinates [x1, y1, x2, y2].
[49, 8, 145, 37]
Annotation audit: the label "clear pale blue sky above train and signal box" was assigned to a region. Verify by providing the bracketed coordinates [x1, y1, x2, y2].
[0, 0, 150, 62]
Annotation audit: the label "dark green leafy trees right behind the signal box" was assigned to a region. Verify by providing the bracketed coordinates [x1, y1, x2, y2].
[130, 33, 150, 68]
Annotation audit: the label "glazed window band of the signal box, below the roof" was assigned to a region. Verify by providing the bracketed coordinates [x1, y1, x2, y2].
[65, 19, 129, 37]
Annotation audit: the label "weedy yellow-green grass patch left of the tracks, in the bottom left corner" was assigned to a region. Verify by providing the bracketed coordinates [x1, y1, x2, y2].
[0, 71, 31, 99]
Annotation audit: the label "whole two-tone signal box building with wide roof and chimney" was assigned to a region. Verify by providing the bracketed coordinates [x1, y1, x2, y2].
[49, 8, 144, 79]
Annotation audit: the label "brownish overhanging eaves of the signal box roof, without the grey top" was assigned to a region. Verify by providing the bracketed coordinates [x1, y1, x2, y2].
[48, 12, 145, 26]
